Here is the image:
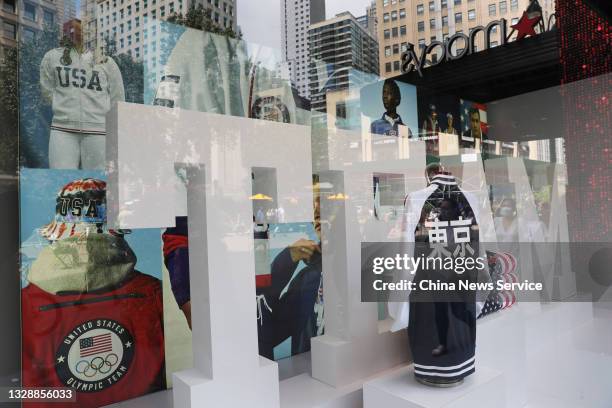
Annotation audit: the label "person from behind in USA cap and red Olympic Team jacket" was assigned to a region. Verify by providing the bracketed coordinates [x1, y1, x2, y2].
[21, 176, 165, 408]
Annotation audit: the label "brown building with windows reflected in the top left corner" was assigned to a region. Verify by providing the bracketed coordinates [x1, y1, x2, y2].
[0, 0, 59, 51]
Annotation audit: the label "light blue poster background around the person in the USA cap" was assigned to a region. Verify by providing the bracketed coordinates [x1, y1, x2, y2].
[19, 168, 161, 279]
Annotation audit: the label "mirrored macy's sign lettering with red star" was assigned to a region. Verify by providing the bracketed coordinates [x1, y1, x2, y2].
[401, 12, 552, 77]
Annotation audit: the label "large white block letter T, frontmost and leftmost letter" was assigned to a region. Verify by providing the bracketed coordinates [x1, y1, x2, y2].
[107, 103, 313, 408]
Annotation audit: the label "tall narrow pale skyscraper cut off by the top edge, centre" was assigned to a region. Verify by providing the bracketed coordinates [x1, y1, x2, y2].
[281, 0, 325, 98]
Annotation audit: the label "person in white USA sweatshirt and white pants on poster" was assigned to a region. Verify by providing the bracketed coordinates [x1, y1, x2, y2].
[40, 31, 125, 169]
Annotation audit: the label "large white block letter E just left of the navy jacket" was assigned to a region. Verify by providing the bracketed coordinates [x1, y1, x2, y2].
[311, 129, 425, 387]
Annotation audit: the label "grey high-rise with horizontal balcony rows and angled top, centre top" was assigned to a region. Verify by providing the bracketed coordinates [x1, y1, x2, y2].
[309, 12, 378, 112]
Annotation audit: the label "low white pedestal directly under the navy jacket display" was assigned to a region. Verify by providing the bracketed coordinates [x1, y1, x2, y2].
[363, 365, 506, 408]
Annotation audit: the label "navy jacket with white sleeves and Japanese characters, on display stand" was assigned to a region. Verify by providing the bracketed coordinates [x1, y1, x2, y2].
[389, 163, 490, 387]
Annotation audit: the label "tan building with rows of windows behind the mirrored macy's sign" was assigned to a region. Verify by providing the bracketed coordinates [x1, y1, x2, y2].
[376, 0, 554, 77]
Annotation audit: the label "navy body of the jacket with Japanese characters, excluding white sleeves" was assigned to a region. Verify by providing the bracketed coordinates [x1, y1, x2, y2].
[408, 178, 479, 381]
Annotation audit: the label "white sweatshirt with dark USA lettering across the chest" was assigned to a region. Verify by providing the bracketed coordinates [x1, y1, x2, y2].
[40, 48, 125, 134]
